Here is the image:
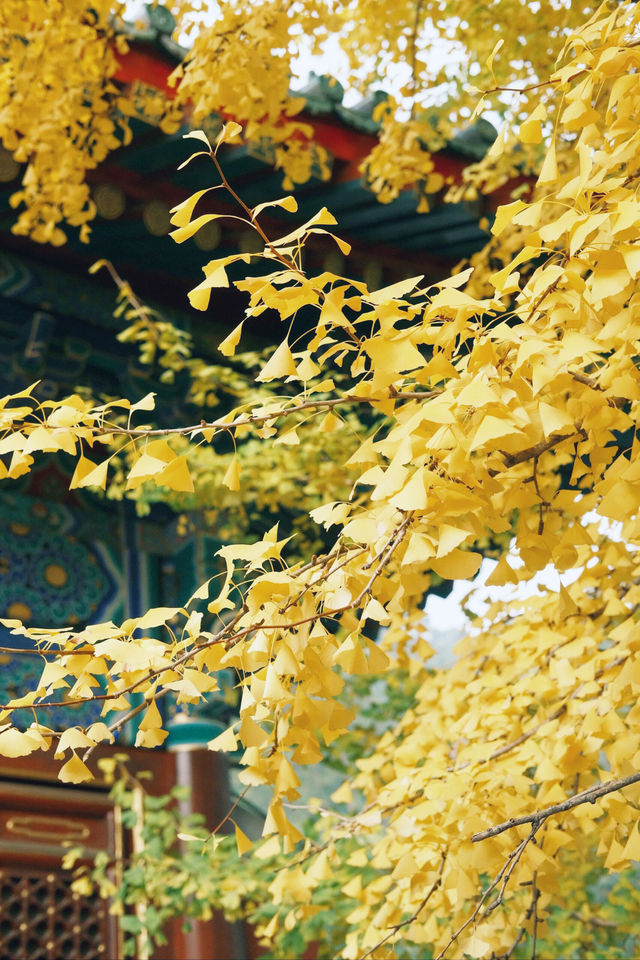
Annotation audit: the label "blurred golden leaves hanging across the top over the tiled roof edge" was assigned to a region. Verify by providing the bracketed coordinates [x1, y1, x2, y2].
[0, 0, 600, 244]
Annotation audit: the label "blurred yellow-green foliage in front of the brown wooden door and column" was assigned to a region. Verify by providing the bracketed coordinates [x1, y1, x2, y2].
[70, 755, 368, 960]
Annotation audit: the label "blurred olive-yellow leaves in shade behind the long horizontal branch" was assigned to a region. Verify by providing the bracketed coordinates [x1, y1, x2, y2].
[91, 258, 371, 555]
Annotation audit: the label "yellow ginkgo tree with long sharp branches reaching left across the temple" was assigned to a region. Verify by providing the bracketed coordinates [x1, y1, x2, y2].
[0, 3, 640, 960]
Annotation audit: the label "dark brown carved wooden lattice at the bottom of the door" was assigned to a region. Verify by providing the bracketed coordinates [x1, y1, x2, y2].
[0, 867, 110, 960]
